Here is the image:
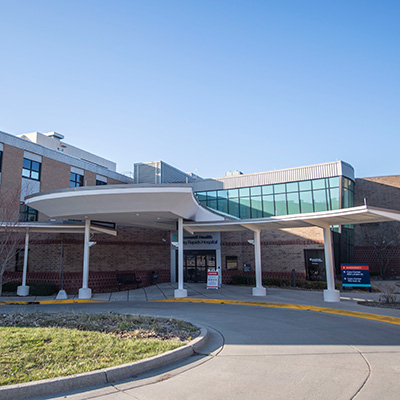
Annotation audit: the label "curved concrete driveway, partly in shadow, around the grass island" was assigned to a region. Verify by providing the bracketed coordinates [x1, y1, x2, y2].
[0, 294, 400, 400]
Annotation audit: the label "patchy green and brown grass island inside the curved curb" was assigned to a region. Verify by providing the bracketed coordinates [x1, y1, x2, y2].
[0, 313, 198, 385]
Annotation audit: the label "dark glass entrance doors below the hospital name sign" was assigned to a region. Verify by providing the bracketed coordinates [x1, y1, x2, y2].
[183, 250, 216, 282]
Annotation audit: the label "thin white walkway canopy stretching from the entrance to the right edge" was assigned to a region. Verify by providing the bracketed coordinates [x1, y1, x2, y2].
[184, 206, 400, 233]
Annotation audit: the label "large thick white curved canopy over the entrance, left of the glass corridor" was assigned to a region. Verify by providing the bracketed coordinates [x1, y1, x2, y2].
[25, 185, 224, 229]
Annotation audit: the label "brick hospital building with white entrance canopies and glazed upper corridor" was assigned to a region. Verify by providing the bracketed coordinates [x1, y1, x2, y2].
[0, 132, 400, 301]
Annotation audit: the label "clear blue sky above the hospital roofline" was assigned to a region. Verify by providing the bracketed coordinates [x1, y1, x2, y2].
[0, 0, 400, 177]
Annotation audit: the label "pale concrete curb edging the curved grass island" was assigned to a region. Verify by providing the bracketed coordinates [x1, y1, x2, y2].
[0, 325, 209, 400]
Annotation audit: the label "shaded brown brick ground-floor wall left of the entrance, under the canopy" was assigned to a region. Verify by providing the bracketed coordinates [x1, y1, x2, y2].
[4, 227, 170, 293]
